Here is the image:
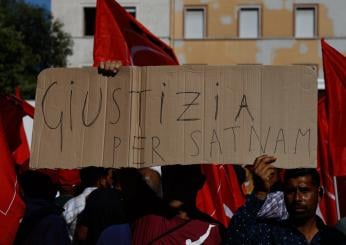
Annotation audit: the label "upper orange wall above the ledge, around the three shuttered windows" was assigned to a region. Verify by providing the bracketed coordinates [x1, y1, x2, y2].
[172, 0, 336, 39]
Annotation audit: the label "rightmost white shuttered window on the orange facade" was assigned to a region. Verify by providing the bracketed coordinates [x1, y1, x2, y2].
[294, 5, 317, 38]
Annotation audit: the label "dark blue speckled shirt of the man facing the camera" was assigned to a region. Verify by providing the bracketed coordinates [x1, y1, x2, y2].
[225, 194, 346, 245]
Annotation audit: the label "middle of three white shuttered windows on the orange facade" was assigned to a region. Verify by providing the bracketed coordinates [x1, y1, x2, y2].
[238, 7, 260, 38]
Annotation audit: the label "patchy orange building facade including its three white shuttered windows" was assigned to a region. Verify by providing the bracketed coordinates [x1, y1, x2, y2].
[171, 0, 346, 88]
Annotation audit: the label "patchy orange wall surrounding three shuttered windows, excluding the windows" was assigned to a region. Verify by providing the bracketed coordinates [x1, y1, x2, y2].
[171, 0, 346, 85]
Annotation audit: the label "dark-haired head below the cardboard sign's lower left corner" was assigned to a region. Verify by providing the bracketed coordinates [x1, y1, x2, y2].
[19, 170, 57, 201]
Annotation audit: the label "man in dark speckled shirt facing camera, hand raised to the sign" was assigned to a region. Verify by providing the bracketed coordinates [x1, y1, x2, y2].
[225, 155, 346, 244]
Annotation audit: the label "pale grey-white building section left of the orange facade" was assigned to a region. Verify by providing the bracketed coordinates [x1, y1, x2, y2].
[51, 0, 170, 67]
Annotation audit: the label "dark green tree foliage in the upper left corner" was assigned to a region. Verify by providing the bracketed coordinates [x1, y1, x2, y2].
[0, 0, 72, 99]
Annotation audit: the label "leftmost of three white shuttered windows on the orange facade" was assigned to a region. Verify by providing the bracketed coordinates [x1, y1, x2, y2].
[184, 8, 205, 39]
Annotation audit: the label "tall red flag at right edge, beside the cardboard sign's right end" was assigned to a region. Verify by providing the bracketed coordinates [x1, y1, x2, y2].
[321, 39, 346, 176]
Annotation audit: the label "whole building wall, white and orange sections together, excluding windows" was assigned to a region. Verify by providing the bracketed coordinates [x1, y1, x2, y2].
[52, 0, 346, 86]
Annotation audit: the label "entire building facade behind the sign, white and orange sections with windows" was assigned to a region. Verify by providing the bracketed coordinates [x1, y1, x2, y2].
[52, 0, 346, 88]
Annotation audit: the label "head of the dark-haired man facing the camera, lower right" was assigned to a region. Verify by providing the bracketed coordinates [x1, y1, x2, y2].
[284, 168, 323, 223]
